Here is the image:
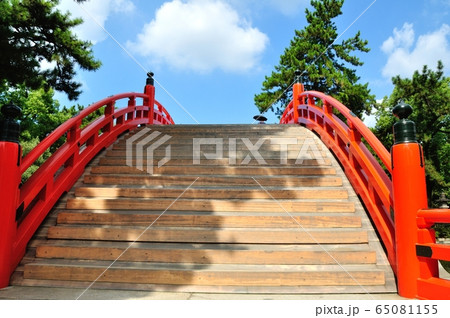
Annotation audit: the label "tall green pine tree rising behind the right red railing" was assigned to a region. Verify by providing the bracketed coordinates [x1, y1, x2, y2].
[255, 0, 375, 116]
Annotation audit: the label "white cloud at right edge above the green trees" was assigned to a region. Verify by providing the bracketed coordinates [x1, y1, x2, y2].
[381, 23, 450, 78]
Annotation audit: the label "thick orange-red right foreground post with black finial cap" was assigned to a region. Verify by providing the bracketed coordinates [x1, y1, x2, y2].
[391, 103, 437, 298]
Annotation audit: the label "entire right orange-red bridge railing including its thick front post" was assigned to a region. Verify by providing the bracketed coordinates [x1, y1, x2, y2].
[280, 78, 450, 299]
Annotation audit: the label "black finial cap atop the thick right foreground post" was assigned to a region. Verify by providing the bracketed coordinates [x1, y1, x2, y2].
[392, 101, 417, 144]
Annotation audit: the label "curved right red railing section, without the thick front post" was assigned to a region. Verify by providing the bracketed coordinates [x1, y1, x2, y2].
[280, 84, 396, 272]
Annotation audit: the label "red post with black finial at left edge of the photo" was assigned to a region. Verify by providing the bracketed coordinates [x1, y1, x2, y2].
[0, 105, 22, 288]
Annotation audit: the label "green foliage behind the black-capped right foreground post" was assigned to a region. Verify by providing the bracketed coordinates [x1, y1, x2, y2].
[374, 62, 450, 207]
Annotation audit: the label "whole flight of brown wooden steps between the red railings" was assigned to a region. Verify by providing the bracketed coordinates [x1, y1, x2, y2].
[13, 125, 395, 294]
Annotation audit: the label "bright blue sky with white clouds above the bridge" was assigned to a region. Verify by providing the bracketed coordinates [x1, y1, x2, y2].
[56, 0, 450, 124]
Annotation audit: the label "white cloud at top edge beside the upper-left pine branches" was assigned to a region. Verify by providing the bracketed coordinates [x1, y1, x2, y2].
[58, 0, 135, 44]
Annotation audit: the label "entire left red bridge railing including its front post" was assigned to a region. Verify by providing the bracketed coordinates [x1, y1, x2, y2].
[0, 77, 174, 288]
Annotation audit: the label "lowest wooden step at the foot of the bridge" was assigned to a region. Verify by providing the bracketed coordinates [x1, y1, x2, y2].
[24, 261, 385, 286]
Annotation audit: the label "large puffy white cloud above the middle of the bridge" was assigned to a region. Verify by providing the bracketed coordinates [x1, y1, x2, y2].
[127, 0, 269, 72]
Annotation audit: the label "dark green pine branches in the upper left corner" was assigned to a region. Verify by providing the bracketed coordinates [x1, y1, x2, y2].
[0, 0, 101, 100]
